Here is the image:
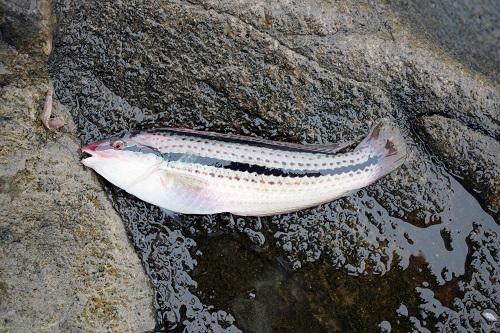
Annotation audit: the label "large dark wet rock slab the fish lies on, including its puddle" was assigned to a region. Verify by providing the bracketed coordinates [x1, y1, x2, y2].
[46, 0, 500, 332]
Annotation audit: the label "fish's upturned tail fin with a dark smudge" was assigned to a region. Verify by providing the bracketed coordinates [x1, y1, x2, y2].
[355, 118, 406, 179]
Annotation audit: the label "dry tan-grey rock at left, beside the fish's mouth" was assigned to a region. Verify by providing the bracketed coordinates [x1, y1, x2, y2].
[0, 1, 154, 332]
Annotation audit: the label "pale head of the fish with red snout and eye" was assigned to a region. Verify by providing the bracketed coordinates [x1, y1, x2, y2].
[81, 135, 163, 190]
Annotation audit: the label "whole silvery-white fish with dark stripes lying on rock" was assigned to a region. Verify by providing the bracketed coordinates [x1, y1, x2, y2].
[81, 119, 407, 216]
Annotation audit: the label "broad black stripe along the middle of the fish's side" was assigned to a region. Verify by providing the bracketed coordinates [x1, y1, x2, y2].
[162, 153, 380, 178]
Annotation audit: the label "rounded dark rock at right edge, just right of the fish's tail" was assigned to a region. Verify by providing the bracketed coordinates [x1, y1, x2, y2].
[417, 115, 500, 218]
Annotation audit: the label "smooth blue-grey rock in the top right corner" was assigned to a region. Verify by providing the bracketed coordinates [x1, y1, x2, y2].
[388, 0, 500, 82]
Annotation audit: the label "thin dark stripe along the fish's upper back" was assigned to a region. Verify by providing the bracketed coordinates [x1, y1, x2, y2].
[147, 128, 336, 154]
